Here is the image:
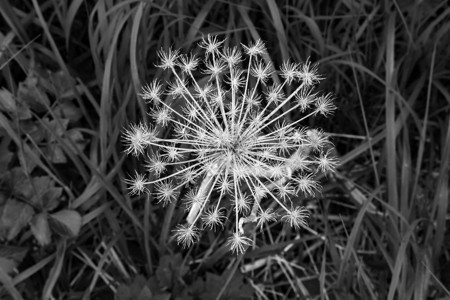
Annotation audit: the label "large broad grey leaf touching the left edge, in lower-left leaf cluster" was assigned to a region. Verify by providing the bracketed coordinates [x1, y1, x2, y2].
[0, 198, 33, 241]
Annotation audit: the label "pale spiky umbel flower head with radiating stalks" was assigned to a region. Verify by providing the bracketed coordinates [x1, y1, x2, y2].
[124, 36, 336, 253]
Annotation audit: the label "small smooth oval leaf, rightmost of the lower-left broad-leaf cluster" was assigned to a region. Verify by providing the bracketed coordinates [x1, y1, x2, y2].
[49, 209, 82, 237]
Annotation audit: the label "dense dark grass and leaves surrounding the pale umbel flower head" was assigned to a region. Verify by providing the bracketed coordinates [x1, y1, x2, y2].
[0, 0, 450, 299]
